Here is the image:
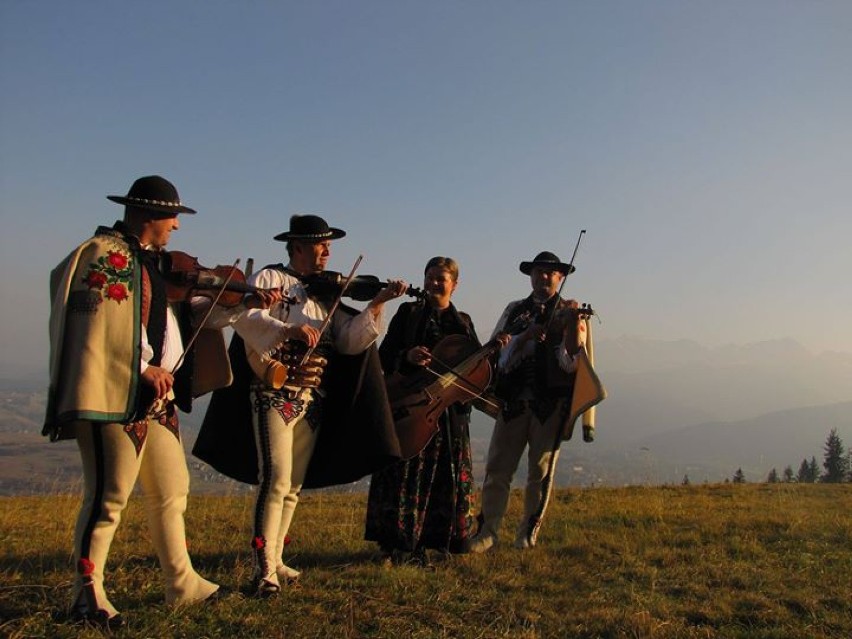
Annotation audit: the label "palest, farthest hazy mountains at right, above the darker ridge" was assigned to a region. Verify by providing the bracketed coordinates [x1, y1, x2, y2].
[596, 337, 852, 446]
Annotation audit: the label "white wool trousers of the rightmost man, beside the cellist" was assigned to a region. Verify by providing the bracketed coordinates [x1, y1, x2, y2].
[478, 402, 563, 540]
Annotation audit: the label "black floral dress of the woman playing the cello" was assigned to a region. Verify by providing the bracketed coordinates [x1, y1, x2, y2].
[364, 302, 479, 553]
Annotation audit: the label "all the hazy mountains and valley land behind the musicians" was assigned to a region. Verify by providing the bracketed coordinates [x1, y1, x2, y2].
[0, 337, 852, 494]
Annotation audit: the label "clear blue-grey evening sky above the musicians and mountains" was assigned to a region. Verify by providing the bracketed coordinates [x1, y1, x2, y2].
[0, 0, 852, 376]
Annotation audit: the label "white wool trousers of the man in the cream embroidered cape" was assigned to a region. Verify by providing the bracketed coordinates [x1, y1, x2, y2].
[74, 412, 218, 616]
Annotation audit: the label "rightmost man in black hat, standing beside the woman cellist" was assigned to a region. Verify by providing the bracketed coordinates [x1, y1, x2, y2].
[471, 251, 585, 553]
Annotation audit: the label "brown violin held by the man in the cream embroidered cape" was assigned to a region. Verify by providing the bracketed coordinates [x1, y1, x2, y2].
[163, 251, 261, 308]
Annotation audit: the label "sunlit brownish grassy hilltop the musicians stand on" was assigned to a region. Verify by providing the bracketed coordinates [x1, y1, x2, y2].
[0, 484, 852, 639]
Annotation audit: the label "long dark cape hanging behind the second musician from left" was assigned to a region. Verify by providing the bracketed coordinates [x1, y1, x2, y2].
[192, 320, 401, 488]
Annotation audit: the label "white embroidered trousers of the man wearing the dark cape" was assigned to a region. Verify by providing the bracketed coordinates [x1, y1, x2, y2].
[252, 389, 319, 585]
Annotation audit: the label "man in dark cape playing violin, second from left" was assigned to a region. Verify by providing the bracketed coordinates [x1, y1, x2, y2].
[193, 215, 408, 597]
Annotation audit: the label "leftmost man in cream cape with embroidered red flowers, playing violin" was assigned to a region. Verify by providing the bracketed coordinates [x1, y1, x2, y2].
[43, 176, 280, 630]
